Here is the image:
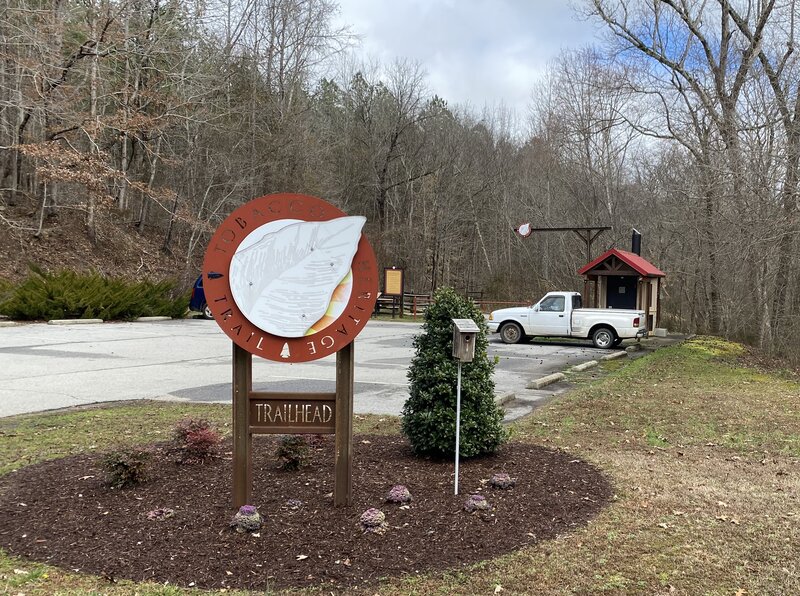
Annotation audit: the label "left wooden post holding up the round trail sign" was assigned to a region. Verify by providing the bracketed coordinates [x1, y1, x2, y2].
[232, 343, 253, 509]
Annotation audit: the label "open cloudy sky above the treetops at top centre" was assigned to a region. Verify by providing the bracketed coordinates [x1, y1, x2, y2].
[339, 0, 599, 114]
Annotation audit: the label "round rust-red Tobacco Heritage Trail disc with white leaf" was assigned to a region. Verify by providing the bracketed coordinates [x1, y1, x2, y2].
[203, 193, 378, 362]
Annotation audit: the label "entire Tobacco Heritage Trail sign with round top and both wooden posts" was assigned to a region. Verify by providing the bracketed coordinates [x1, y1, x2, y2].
[203, 194, 378, 508]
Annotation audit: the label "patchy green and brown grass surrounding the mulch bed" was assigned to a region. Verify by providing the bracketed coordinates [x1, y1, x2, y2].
[0, 338, 800, 595]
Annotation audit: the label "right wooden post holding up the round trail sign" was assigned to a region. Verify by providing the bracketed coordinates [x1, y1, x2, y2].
[333, 342, 355, 507]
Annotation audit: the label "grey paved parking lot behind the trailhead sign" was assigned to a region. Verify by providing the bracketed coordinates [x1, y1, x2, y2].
[0, 319, 606, 416]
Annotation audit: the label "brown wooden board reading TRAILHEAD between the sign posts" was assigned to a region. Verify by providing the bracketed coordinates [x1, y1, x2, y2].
[250, 392, 336, 434]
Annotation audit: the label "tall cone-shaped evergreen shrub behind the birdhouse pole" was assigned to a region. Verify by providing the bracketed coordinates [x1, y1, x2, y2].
[402, 288, 508, 458]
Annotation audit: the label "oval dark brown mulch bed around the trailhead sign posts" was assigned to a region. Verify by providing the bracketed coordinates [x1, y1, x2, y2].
[0, 436, 612, 589]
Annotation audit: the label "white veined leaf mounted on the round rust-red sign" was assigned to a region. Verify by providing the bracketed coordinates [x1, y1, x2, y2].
[229, 216, 367, 337]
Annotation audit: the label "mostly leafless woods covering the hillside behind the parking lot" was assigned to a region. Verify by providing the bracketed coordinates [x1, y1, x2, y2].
[0, 0, 800, 357]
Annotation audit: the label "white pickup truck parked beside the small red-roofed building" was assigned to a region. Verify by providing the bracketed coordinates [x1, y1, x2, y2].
[488, 292, 647, 348]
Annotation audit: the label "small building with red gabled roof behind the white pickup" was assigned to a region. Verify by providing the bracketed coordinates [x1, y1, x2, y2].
[578, 248, 665, 332]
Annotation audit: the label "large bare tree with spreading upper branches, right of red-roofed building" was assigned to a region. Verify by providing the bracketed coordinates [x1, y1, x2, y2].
[589, 0, 775, 332]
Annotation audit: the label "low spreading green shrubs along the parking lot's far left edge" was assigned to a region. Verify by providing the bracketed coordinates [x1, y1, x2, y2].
[0, 266, 189, 321]
